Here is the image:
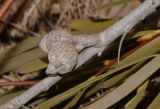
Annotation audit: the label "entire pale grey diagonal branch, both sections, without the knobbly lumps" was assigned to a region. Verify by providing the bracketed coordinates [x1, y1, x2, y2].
[0, 0, 160, 109]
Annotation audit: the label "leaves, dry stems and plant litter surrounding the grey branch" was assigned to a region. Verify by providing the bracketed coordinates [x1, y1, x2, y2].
[0, 0, 160, 109]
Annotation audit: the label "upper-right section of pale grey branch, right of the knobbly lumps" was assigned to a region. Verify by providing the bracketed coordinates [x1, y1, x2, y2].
[77, 0, 160, 67]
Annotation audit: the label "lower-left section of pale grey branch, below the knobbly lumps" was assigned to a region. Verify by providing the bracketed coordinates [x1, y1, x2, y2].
[0, 76, 61, 109]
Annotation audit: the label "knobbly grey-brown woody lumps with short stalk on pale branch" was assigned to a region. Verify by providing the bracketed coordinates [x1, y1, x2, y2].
[39, 30, 99, 76]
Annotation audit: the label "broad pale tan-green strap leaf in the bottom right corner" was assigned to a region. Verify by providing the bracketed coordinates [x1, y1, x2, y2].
[84, 55, 160, 109]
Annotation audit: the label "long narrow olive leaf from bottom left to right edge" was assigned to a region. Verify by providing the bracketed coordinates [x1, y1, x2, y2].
[34, 55, 159, 109]
